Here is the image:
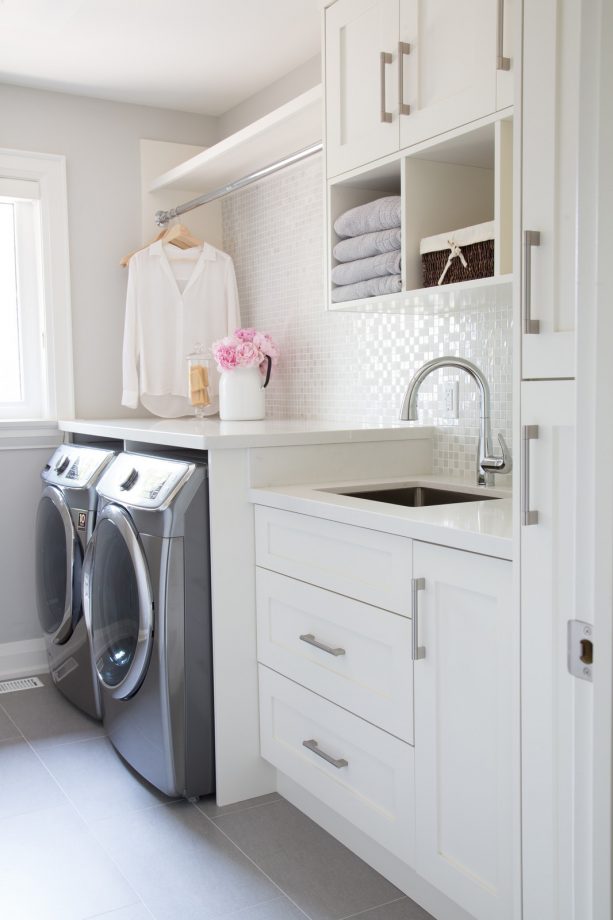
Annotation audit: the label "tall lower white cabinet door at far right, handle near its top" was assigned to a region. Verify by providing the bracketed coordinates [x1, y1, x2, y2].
[520, 380, 593, 920]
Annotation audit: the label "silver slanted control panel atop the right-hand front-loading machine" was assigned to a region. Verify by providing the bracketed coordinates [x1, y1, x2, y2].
[96, 453, 195, 511]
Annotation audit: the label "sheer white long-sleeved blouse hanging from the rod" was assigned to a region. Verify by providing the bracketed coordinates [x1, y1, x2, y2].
[121, 241, 240, 418]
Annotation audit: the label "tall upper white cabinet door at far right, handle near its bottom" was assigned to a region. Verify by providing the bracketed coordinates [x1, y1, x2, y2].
[521, 0, 581, 380]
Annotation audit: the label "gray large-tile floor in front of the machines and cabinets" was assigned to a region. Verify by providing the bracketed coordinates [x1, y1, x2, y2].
[0, 676, 430, 920]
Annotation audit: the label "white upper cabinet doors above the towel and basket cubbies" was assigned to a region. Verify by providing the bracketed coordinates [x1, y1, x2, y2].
[325, 0, 513, 177]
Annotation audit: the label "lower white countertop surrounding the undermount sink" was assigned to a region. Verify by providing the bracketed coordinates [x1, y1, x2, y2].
[249, 476, 513, 559]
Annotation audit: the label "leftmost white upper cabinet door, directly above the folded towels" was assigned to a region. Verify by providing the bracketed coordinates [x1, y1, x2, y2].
[325, 0, 398, 176]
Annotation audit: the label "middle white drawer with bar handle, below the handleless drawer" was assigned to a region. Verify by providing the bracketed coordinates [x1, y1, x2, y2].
[256, 568, 413, 743]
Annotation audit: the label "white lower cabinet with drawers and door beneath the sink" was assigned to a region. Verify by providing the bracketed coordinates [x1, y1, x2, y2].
[256, 509, 519, 920]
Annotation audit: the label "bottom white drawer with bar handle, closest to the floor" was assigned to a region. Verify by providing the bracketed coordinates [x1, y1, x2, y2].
[259, 665, 415, 864]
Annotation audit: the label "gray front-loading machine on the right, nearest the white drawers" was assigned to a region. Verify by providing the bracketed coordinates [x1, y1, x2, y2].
[83, 453, 215, 798]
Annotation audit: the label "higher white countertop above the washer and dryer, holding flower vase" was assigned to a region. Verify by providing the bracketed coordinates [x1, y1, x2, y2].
[58, 417, 433, 450]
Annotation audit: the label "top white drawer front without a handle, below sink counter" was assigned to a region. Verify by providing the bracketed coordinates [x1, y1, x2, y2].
[255, 505, 412, 616]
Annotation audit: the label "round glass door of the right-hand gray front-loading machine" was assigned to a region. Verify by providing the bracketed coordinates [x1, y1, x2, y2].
[83, 504, 153, 699]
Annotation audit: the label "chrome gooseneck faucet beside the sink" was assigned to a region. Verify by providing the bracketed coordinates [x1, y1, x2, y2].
[400, 355, 513, 486]
